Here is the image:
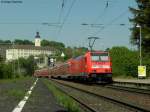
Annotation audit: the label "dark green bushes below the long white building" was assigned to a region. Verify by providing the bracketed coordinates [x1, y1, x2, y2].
[0, 56, 37, 79]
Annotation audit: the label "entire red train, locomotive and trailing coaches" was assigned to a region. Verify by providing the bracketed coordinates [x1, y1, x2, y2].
[34, 51, 112, 83]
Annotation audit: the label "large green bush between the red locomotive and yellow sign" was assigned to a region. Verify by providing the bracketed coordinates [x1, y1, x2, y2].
[110, 47, 139, 77]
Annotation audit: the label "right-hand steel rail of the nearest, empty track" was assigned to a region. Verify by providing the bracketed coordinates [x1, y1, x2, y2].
[53, 80, 150, 112]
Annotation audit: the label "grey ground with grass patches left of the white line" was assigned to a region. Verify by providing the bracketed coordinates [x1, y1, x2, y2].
[0, 78, 34, 112]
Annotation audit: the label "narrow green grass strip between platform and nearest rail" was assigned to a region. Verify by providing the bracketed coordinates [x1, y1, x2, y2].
[44, 79, 82, 112]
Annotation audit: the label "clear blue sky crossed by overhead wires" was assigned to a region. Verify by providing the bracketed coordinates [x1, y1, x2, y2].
[0, 0, 136, 50]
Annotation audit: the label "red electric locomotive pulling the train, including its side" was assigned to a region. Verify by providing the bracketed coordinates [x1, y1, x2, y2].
[68, 51, 112, 82]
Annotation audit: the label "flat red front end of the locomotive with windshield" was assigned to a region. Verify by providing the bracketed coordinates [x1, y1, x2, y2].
[88, 52, 112, 82]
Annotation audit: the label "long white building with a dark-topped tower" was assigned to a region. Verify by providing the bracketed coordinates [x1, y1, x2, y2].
[6, 32, 54, 66]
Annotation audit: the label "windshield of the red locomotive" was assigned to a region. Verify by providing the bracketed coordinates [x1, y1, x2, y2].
[91, 53, 109, 62]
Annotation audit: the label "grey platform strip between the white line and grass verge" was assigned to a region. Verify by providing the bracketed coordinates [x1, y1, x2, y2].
[22, 79, 65, 112]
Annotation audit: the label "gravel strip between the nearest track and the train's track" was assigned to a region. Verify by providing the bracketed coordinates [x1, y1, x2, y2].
[54, 80, 150, 110]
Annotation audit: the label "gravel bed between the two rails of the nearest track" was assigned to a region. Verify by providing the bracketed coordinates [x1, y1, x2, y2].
[53, 82, 134, 112]
